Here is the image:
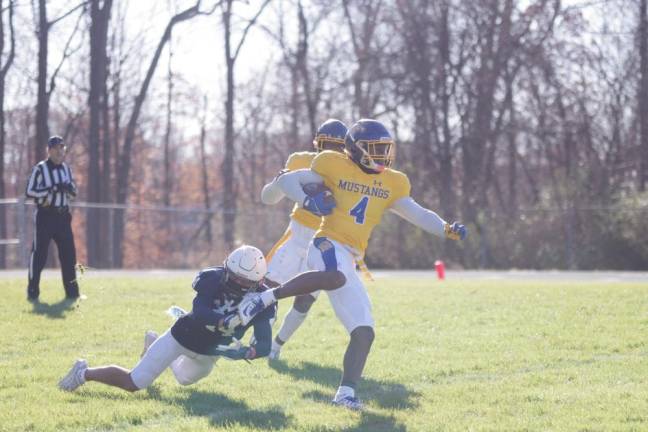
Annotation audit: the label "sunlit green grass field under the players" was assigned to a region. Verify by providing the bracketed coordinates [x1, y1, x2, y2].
[0, 277, 648, 432]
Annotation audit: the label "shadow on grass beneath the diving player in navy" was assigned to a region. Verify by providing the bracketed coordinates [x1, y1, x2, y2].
[157, 389, 290, 430]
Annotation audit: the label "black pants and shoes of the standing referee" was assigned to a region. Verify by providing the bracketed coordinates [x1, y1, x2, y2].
[27, 207, 79, 299]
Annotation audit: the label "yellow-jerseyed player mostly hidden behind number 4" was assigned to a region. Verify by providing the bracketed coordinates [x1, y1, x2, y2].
[261, 119, 347, 360]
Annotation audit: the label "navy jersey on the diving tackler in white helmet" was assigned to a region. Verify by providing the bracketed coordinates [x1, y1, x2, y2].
[171, 267, 276, 357]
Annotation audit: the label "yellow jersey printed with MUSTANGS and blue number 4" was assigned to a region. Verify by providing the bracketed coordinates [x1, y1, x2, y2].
[311, 151, 411, 254]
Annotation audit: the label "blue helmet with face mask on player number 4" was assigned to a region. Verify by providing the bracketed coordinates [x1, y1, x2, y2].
[344, 119, 395, 173]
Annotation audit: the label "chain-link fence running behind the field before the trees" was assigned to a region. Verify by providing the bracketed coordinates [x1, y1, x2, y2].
[0, 199, 648, 270]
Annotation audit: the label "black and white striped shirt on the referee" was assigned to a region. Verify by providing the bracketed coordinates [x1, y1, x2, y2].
[25, 159, 77, 207]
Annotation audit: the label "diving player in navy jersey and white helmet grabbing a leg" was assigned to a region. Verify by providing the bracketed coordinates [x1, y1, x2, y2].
[59, 245, 345, 391]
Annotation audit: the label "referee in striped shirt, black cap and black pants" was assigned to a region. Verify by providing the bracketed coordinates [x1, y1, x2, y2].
[25, 136, 79, 302]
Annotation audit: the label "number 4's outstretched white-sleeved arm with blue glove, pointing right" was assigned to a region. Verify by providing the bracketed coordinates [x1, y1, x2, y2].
[390, 197, 467, 240]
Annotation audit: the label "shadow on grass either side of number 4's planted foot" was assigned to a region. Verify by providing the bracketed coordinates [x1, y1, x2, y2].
[270, 360, 421, 409]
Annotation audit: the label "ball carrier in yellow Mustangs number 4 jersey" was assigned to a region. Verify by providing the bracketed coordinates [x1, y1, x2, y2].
[260, 119, 466, 409]
